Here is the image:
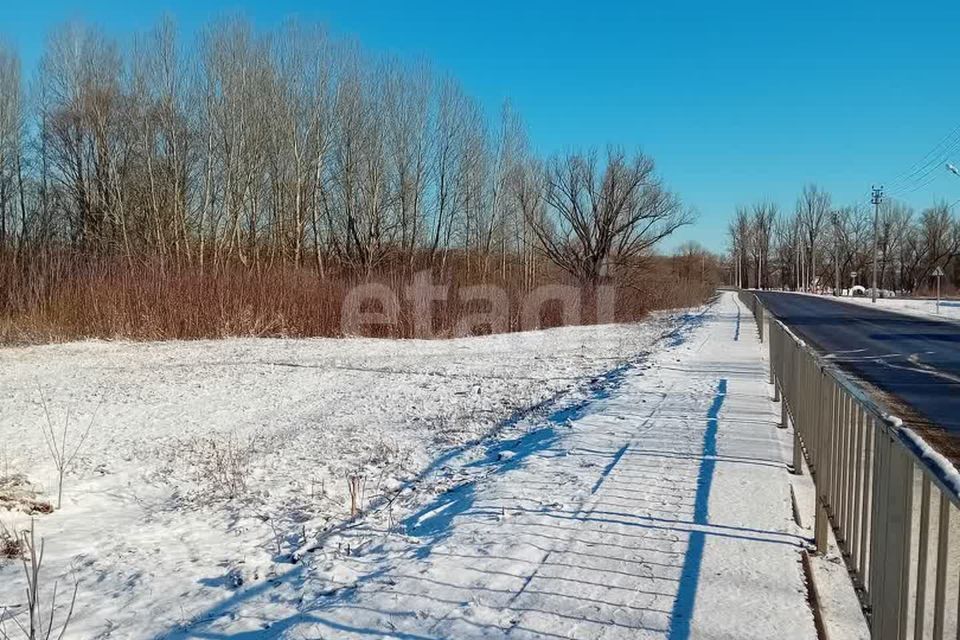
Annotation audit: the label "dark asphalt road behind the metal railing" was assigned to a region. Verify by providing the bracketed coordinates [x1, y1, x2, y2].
[758, 292, 960, 457]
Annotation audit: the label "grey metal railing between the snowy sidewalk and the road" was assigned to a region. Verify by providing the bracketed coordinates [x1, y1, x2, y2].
[740, 291, 960, 640]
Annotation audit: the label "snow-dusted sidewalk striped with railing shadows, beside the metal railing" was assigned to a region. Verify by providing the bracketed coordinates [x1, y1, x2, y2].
[191, 293, 816, 640]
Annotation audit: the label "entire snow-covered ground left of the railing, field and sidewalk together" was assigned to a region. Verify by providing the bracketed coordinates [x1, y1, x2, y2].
[0, 293, 815, 638]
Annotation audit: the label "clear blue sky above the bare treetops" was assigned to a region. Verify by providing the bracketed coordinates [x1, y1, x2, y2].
[0, 0, 960, 250]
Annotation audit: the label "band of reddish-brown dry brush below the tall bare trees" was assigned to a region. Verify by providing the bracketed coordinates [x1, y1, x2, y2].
[0, 251, 713, 344]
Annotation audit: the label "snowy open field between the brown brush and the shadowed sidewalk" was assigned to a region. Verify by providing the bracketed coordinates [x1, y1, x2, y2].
[0, 314, 692, 638]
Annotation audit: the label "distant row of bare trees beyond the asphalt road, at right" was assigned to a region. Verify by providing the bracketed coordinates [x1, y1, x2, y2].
[727, 184, 960, 293]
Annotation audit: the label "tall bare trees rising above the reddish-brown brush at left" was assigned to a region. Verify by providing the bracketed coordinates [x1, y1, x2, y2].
[0, 18, 692, 296]
